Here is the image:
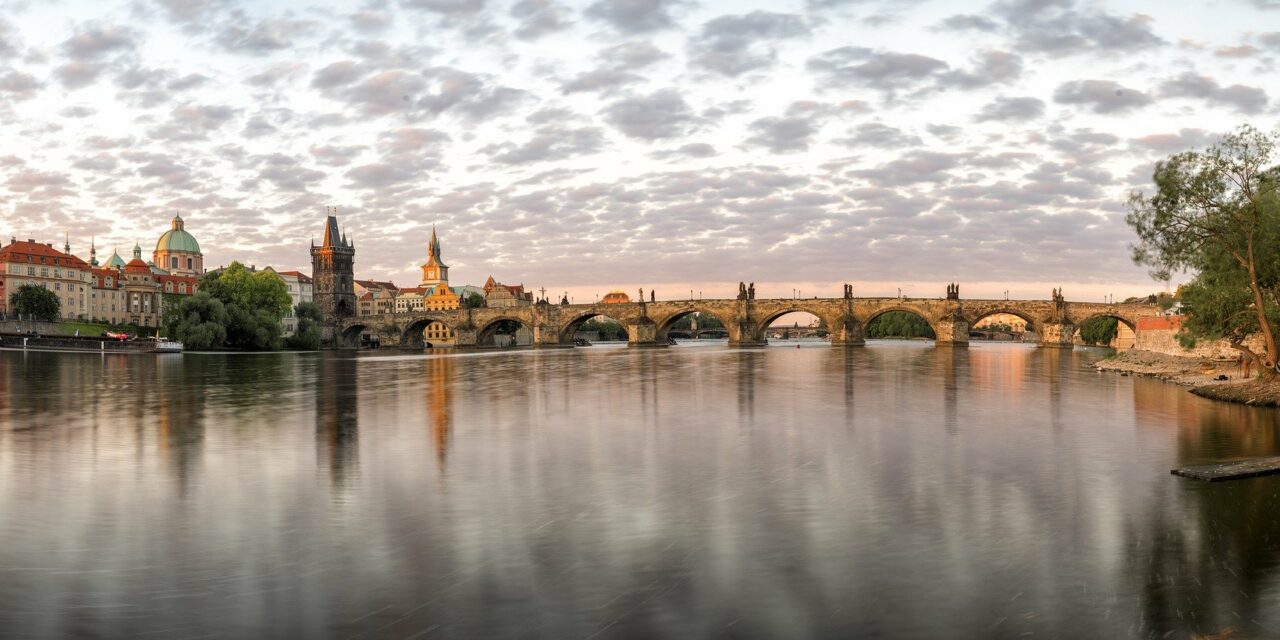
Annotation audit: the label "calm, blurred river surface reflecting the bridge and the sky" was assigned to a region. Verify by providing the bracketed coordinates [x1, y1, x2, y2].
[0, 343, 1280, 639]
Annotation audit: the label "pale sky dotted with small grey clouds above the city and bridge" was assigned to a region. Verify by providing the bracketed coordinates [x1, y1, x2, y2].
[0, 0, 1280, 302]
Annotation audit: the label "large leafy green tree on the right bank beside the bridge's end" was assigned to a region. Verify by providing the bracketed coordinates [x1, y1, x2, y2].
[1125, 127, 1280, 378]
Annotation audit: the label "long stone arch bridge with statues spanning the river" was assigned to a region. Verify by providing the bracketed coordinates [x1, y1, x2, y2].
[333, 298, 1158, 348]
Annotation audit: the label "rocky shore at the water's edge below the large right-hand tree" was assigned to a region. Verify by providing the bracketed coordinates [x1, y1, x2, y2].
[1093, 349, 1280, 407]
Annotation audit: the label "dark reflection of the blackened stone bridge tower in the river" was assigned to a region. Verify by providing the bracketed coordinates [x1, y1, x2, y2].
[316, 355, 360, 486]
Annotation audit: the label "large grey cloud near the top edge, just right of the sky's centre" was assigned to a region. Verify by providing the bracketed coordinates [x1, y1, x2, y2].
[689, 12, 809, 77]
